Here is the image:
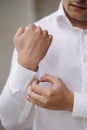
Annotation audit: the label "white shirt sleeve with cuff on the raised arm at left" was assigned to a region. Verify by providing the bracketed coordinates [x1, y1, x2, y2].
[0, 50, 40, 130]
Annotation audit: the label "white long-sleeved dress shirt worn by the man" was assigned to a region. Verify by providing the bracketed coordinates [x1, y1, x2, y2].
[0, 3, 87, 130]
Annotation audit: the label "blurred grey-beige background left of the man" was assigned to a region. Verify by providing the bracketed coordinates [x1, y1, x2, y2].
[0, 0, 60, 130]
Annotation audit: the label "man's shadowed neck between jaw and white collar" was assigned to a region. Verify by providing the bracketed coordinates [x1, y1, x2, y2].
[65, 8, 87, 30]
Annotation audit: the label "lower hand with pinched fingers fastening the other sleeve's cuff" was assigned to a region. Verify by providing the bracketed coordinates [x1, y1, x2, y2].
[27, 75, 74, 111]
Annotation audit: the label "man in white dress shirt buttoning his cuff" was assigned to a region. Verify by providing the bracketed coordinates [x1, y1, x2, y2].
[0, 0, 87, 130]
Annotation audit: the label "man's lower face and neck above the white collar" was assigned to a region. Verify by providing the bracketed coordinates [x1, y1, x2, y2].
[63, 0, 87, 29]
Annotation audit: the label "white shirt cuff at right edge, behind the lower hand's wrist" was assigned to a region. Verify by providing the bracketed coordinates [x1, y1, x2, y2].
[72, 92, 87, 118]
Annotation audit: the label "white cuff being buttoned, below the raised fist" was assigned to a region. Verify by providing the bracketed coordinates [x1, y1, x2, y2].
[11, 63, 40, 90]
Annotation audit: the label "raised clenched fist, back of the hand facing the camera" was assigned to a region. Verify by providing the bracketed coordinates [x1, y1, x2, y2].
[13, 24, 52, 71]
